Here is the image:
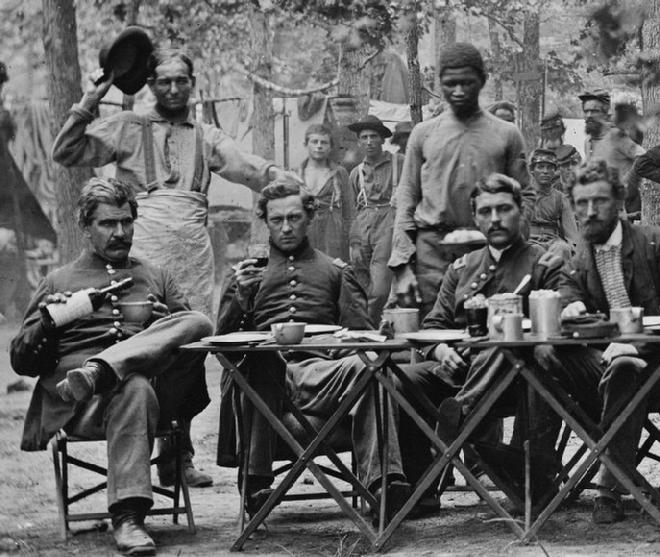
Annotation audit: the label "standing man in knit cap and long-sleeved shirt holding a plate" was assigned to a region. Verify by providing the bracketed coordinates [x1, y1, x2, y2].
[389, 43, 534, 317]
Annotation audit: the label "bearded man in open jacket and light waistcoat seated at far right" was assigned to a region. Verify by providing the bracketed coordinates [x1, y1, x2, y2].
[540, 159, 660, 524]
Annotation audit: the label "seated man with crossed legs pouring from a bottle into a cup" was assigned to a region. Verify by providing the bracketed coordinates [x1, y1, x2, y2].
[10, 178, 212, 555]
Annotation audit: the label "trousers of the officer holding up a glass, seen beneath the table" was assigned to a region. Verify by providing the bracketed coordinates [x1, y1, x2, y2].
[246, 353, 403, 486]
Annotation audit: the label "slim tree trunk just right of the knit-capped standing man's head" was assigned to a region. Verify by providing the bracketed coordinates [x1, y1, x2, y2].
[518, 8, 543, 151]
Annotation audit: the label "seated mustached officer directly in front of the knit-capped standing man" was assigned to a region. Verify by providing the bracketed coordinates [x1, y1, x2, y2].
[399, 174, 561, 511]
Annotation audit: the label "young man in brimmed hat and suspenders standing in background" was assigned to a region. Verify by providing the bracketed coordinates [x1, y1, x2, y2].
[348, 115, 404, 325]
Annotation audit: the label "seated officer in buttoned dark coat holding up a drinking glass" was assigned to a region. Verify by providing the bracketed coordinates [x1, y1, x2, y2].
[217, 179, 410, 514]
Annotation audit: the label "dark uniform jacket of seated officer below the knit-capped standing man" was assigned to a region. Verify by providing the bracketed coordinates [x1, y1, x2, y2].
[422, 239, 563, 329]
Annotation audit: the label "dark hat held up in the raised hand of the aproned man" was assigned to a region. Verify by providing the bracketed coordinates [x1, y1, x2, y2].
[99, 25, 154, 95]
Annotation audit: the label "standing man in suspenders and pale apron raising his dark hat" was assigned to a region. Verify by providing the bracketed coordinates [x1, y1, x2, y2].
[52, 27, 300, 487]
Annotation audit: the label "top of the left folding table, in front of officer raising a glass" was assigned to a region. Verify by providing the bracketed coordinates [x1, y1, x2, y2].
[180, 339, 411, 353]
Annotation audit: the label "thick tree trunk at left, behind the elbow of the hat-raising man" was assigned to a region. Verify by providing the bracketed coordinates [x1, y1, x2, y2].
[42, 0, 92, 263]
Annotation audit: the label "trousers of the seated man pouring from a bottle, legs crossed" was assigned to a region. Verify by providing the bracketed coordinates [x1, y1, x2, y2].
[65, 311, 213, 511]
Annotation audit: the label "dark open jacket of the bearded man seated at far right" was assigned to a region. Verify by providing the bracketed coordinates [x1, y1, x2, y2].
[559, 218, 660, 315]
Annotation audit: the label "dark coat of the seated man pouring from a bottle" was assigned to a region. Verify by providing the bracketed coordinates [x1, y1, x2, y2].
[10, 252, 189, 451]
